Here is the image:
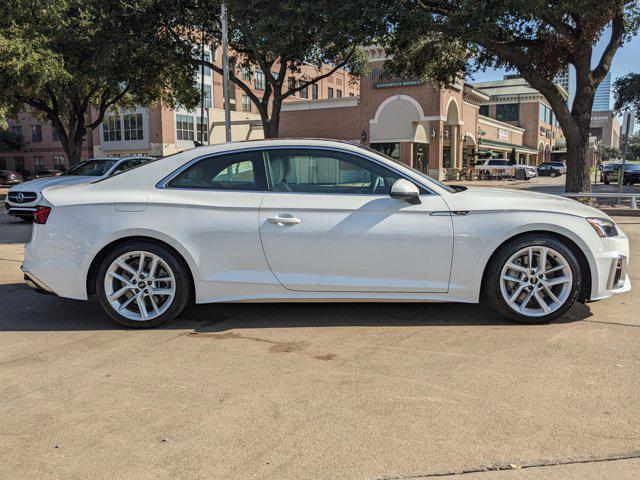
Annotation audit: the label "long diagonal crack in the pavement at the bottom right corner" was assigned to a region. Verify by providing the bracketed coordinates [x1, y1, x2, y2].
[376, 450, 640, 480]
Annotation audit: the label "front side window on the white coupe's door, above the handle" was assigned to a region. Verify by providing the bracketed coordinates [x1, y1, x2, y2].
[267, 149, 401, 195]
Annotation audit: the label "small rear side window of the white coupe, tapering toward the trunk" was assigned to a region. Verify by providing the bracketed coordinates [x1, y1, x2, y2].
[168, 152, 264, 191]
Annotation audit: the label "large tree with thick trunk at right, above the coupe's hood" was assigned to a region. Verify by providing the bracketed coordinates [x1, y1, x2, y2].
[382, 0, 639, 192]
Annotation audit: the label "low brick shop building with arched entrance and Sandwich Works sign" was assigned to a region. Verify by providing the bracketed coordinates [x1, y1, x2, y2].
[280, 47, 538, 178]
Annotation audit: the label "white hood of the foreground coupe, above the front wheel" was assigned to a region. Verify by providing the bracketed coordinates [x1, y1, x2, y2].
[446, 187, 609, 218]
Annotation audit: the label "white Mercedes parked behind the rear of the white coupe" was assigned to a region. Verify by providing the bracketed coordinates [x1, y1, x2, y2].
[5, 157, 154, 221]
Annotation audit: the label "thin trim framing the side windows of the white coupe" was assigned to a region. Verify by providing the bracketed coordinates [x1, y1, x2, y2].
[155, 145, 439, 197]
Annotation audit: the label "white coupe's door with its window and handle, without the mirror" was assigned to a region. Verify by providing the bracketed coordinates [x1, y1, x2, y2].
[260, 148, 453, 292]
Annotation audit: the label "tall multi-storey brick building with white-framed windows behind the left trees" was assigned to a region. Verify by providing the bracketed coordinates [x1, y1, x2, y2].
[0, 48, 359, 172]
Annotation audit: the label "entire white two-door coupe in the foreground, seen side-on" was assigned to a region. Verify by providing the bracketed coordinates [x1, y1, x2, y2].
[22, 140, 631, 327]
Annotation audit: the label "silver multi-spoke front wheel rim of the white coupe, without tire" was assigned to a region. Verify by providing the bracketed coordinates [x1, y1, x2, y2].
[500, 246, 573, 317]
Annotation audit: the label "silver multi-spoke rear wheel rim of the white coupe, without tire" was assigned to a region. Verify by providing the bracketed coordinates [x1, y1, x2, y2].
[104, 251, 176, 321]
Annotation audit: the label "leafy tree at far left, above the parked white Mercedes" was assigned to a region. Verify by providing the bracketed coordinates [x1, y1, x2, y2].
[0, 0, 198, 164]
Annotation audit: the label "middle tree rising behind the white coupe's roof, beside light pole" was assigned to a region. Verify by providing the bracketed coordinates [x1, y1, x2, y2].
[157, 0, 380, 138]
